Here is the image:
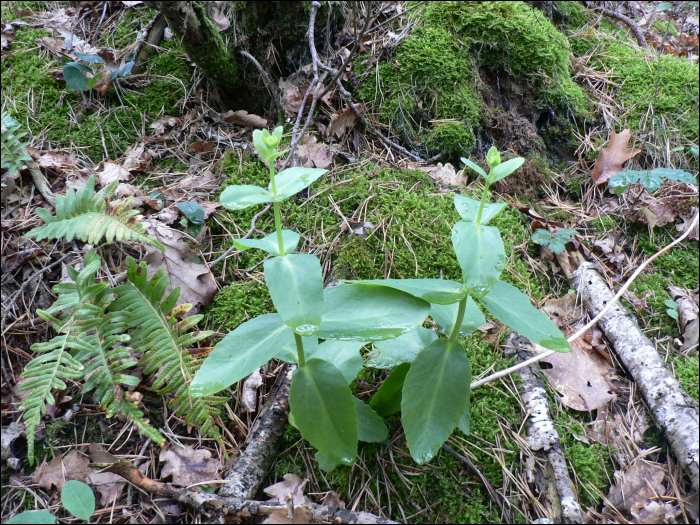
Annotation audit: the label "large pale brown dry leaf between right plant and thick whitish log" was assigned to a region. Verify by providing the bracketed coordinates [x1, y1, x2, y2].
[535, 330, 616, 412]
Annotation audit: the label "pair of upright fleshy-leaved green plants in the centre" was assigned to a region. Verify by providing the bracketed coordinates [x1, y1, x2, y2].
[190, 133, 569, 470]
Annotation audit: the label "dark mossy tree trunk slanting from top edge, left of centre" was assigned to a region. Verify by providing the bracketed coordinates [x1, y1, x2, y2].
[145, 1, 246, 109]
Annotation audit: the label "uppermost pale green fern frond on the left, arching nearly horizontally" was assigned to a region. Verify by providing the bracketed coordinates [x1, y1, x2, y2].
[27, 176, 165, 250]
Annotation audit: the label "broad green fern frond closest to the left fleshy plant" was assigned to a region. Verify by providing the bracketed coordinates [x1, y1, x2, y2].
[110, 257, 227, 441]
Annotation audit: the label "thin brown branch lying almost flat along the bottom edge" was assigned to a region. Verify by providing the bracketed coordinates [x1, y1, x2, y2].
[90, 459, 396, 523]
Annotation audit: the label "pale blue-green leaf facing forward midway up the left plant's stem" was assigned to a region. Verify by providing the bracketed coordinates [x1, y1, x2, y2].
[264, 253, 323, 336]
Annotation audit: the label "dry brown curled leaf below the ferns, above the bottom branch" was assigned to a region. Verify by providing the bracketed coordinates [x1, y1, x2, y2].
[158, 444, 221, 487]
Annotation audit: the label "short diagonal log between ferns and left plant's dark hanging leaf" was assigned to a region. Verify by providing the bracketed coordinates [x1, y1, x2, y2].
[219, 365, 296, 499]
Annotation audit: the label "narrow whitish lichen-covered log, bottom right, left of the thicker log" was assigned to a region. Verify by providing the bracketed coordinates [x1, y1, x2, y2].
[505, 332, 583, 523]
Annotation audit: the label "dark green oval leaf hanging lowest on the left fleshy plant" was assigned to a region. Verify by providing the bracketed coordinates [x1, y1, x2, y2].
[289, 359, 357, 465]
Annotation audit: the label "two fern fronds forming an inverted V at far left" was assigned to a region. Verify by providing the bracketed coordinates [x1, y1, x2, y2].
[19, 251, 164, 463]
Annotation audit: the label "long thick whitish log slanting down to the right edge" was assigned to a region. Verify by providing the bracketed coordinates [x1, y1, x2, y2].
[573, 262, 700, 497]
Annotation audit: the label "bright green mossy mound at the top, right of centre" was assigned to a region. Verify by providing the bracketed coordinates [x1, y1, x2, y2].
[355, 2, 586, 160]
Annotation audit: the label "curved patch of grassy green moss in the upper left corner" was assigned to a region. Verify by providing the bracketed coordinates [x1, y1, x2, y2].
[2, 10, 191, 163]
